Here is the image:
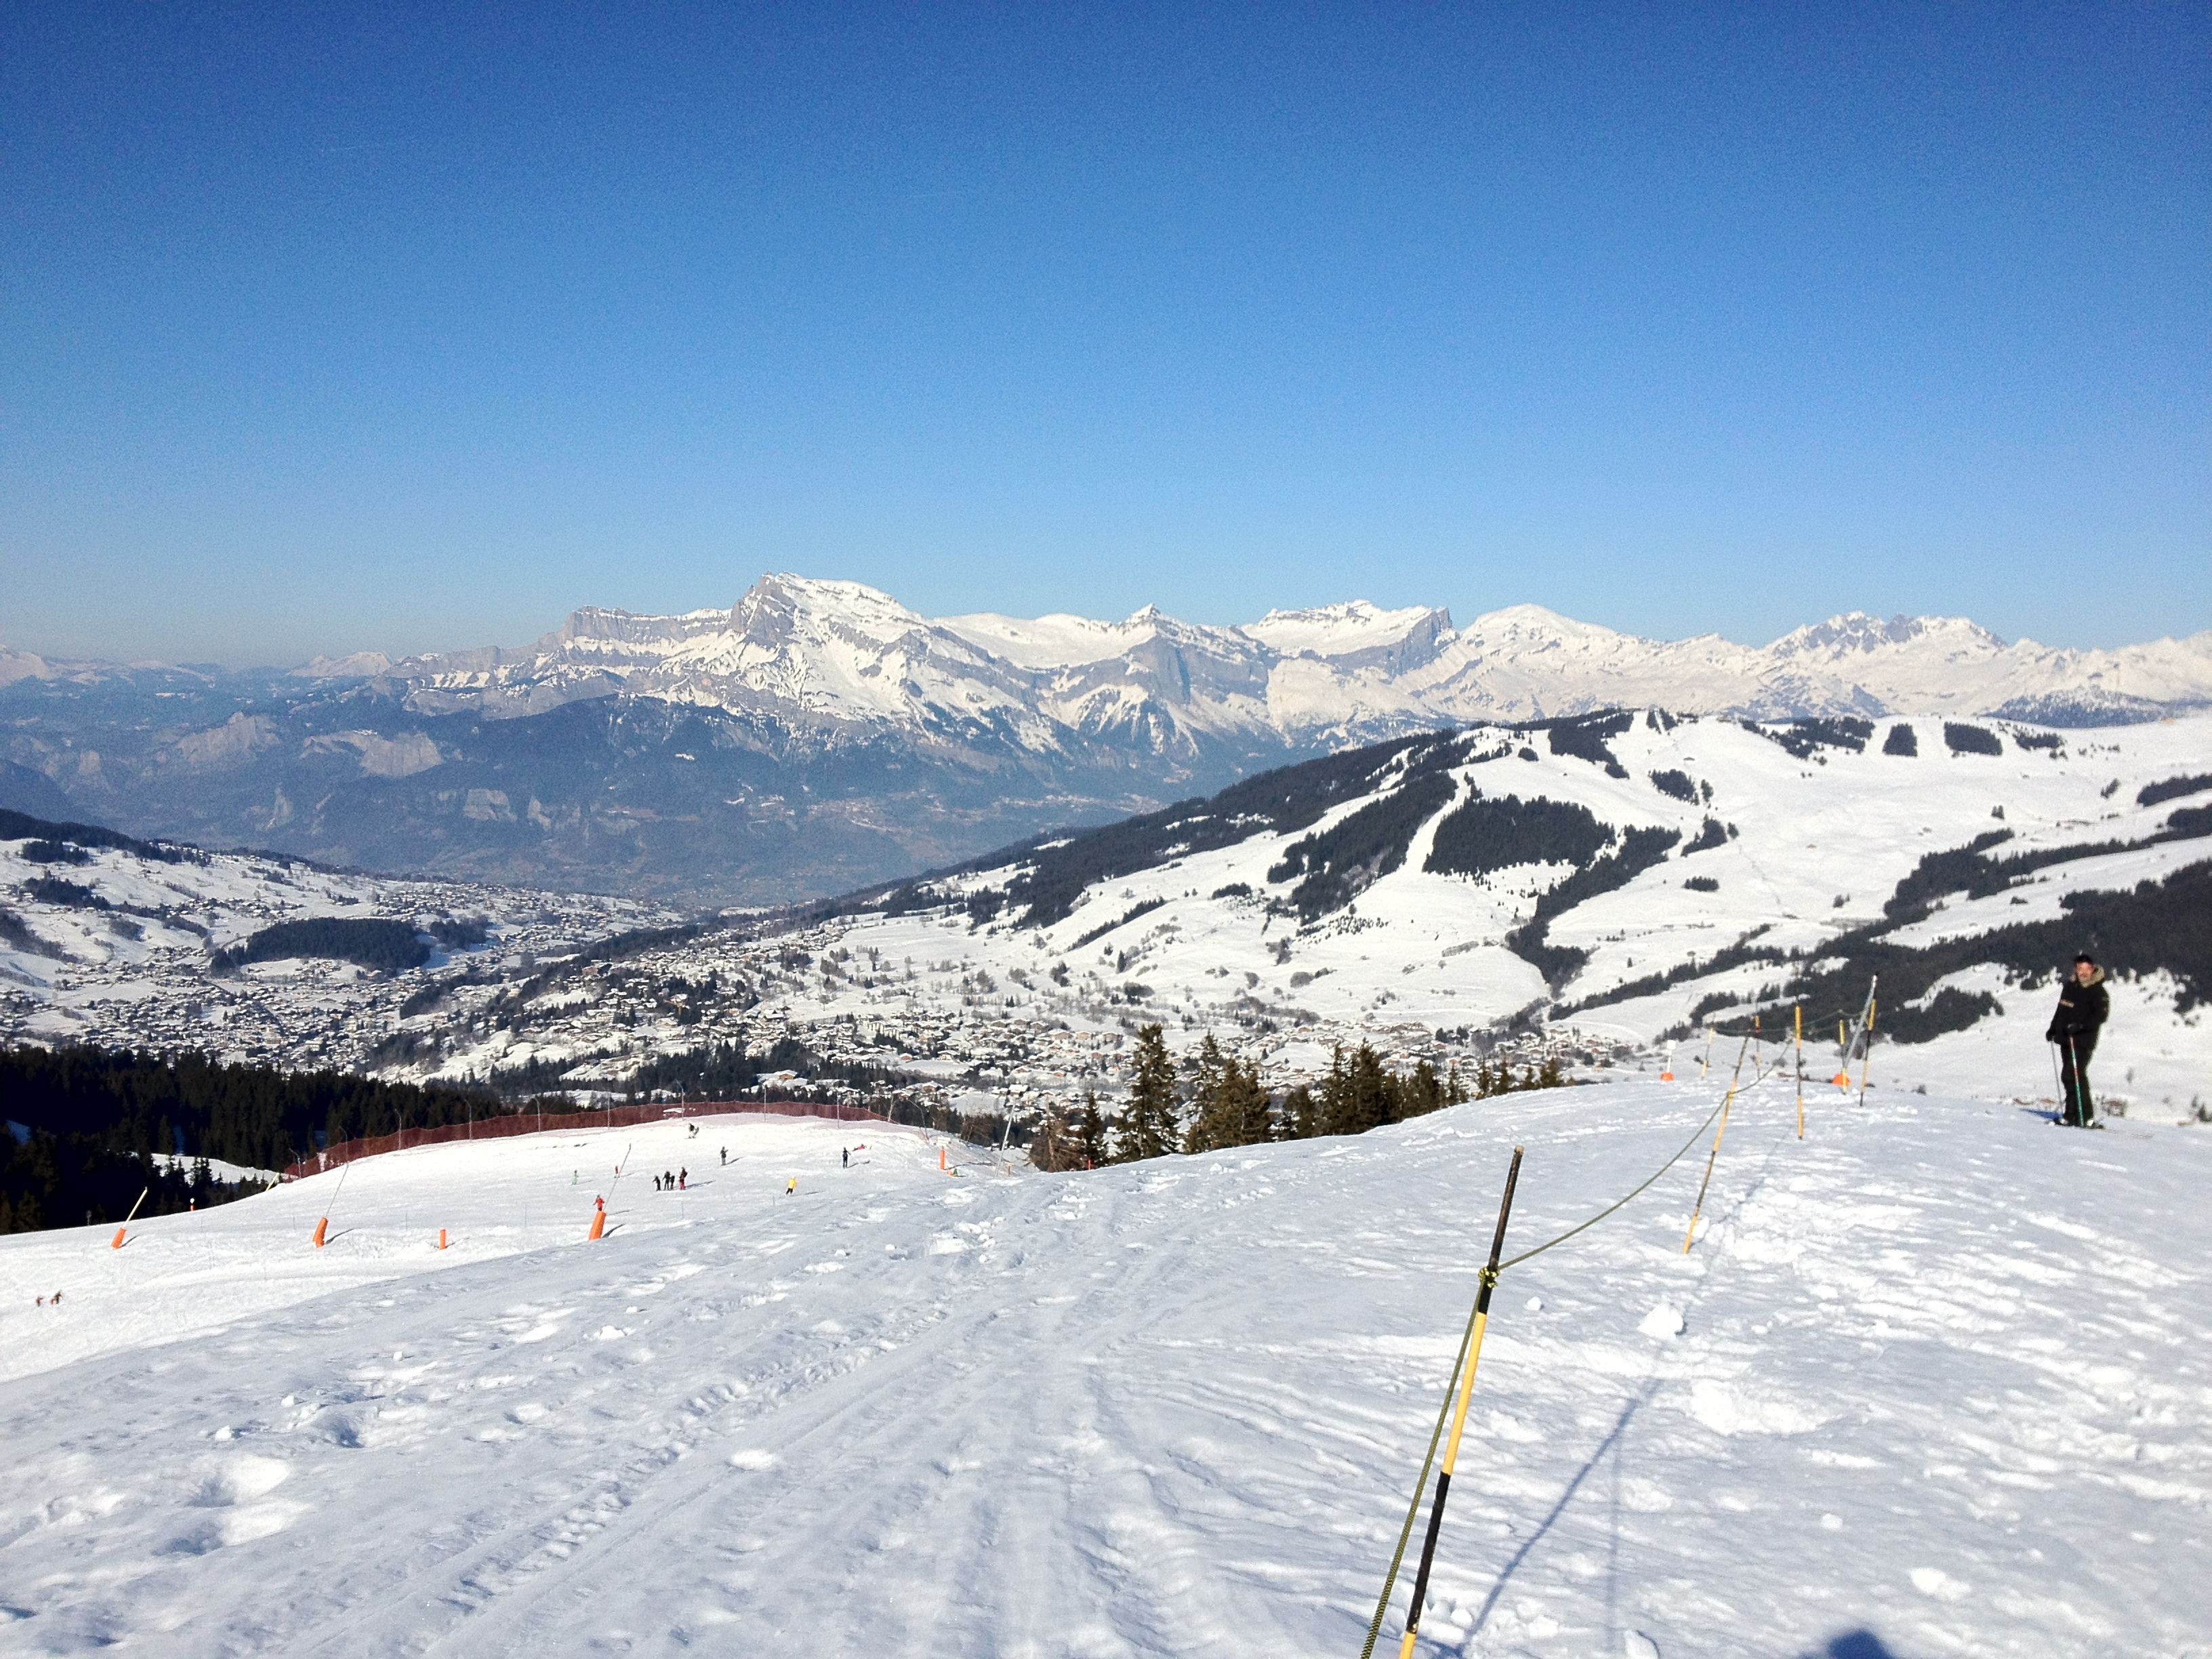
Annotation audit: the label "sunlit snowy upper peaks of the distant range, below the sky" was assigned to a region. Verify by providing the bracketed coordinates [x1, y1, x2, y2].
[323, 575, 2212, 750]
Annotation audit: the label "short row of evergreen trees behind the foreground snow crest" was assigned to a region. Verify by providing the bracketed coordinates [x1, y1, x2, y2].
[1029, 1024, 1566, 1170]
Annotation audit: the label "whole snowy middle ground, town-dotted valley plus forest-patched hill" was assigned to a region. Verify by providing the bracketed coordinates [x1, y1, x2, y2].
[13, 712, 2212, 1122]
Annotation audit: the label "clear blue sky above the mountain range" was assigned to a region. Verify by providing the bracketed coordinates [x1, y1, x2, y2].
[0, 5, 2212, 663]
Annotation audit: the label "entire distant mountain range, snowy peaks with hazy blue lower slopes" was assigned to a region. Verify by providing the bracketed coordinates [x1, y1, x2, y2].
[0, 575, 2212, 903]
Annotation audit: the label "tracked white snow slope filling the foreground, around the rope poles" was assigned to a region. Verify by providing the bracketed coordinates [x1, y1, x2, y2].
[0, 1084, 2212, 1659]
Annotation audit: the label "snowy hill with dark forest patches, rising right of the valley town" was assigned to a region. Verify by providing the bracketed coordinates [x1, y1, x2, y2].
[703, 714, 2212, 1117]
